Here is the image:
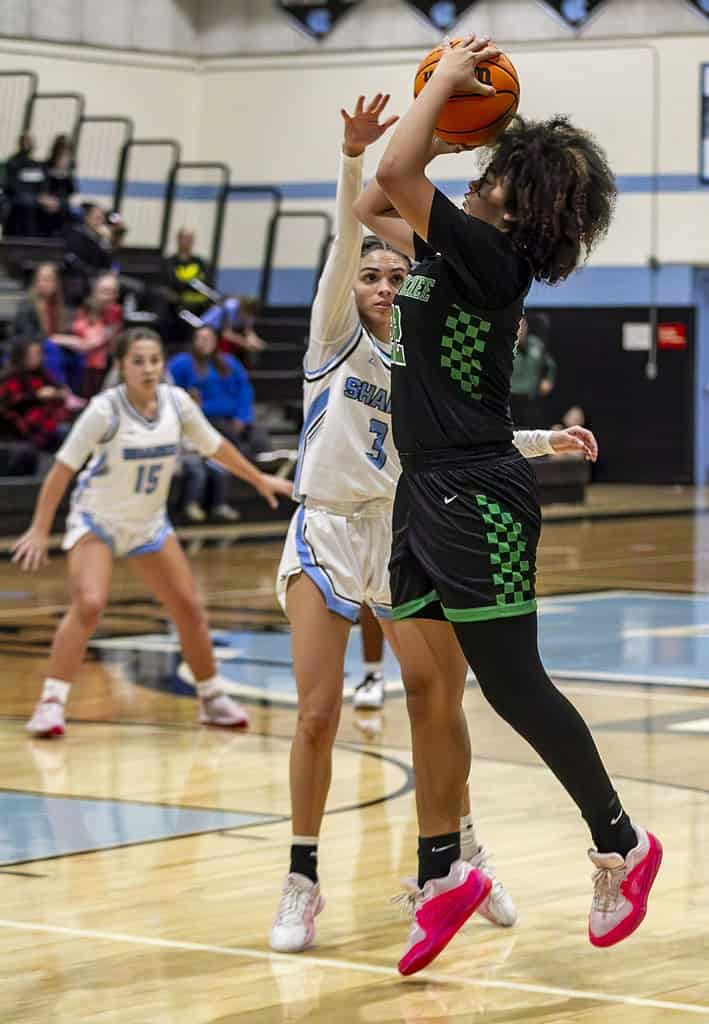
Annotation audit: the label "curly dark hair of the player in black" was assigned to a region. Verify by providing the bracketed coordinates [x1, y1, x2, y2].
[484, 117, 617, 285]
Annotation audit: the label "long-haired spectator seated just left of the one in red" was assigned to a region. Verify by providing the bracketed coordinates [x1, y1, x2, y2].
[13, 263, 84, 393]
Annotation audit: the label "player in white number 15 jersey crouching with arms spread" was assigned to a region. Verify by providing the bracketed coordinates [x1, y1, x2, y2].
[13, 328, 291, 737]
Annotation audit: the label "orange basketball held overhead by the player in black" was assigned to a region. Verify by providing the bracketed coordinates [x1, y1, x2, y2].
[414, 39, 519, 145]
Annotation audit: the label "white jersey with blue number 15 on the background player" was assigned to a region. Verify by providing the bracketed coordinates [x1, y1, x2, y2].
[62, 384, 221, 531]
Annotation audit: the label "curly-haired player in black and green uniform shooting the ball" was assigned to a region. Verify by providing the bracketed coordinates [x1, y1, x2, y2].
[359, 36, 662, 974]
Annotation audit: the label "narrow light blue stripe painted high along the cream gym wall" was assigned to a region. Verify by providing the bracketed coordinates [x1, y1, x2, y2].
[79, 174, 709, 203]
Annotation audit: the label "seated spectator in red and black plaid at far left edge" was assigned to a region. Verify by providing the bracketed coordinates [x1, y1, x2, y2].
[0, 338, 69, 452]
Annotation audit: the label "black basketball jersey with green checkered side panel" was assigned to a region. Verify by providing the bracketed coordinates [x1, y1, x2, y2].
[391, 189, 532, 454]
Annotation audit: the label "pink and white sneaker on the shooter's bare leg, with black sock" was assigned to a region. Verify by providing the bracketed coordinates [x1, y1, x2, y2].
[399, 860, 492, 975]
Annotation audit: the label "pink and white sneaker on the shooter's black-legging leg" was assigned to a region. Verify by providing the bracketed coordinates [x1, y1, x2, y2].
[588, 825, 662, 946]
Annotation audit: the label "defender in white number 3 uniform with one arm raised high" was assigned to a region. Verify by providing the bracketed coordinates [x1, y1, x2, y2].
[270, 94, 590, 952]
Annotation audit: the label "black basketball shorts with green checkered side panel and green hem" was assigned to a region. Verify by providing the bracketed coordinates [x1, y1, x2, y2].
[389, 450, 541, 623]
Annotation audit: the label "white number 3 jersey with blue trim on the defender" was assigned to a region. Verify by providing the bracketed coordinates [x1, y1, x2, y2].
[295, 324, 401, 506]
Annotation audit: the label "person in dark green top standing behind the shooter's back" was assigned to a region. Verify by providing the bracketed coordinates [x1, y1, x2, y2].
[510, 313, 556, 429]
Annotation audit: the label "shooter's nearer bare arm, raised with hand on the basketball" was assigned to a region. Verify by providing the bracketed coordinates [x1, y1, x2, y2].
[377, 36, 500, 241]
